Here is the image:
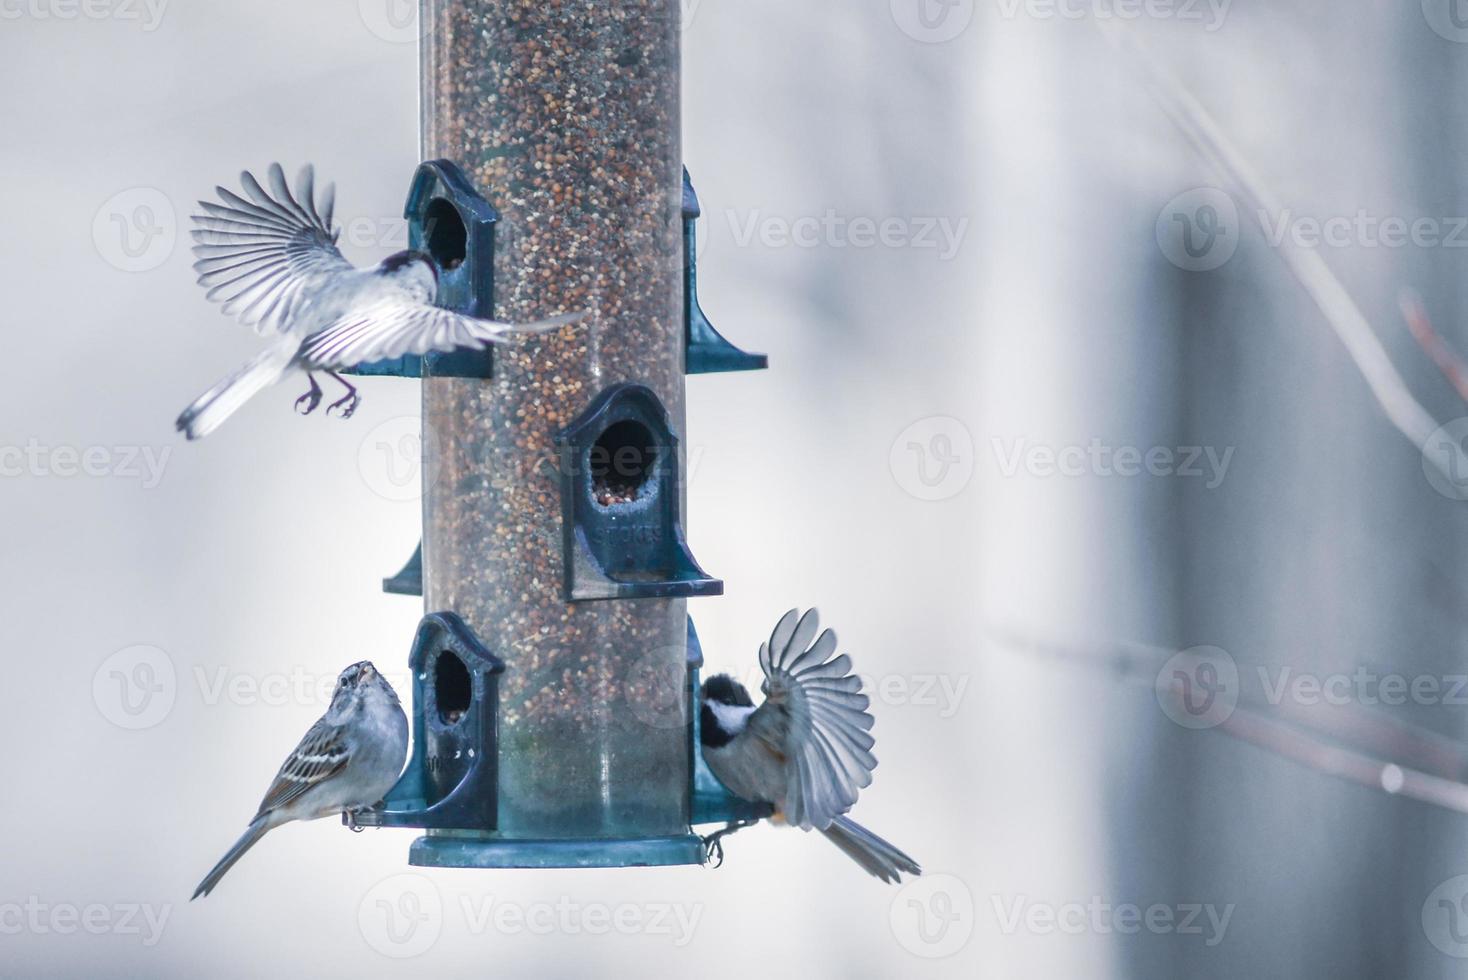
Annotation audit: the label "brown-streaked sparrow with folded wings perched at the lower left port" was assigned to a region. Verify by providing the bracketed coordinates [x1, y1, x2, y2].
[189, 660, 408, 901]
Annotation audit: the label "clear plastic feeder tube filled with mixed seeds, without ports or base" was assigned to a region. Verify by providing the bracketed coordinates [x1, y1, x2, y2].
[421, 0, 690, 839]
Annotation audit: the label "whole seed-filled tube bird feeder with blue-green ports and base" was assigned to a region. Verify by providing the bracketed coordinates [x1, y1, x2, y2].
[358, 0, 765, 867]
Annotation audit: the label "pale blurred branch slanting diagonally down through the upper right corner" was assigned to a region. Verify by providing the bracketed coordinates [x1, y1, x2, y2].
[1095, 21, 1453, 480]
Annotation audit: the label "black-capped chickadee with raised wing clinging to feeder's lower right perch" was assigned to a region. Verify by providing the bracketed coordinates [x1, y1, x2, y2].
[699, 609, 922, 882]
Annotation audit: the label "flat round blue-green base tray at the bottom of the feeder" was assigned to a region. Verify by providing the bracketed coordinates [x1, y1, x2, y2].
[408, 833, 703, 869]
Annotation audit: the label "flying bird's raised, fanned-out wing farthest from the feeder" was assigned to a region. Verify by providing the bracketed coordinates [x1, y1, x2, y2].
[192, 163, 352, 333]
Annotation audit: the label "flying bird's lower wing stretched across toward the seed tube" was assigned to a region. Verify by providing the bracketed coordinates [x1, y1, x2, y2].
[298, 301, 581, 370]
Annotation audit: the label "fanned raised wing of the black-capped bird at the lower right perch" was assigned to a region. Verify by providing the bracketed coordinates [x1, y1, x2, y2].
[749, 609, 876, 830]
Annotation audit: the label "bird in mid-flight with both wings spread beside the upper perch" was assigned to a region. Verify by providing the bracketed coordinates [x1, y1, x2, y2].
[176, 163, 581, 439]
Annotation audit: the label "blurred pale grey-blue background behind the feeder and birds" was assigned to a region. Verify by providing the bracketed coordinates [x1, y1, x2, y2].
[0, 0, 1468, 977]
